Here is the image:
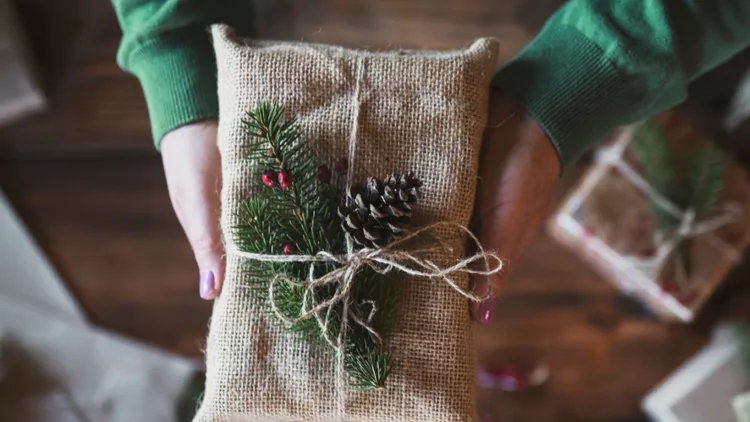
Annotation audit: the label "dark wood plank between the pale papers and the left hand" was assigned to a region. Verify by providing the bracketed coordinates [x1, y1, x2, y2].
[0, 156, 210, 355]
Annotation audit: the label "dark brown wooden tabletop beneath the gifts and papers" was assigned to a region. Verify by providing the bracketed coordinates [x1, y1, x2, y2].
[0, 0, 750, 422]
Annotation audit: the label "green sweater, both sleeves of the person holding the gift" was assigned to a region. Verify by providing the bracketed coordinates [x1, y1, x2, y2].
[113, 0, 750, 168]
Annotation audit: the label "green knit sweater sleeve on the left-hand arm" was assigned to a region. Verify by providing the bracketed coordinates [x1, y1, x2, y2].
[113, 0, 253, 148]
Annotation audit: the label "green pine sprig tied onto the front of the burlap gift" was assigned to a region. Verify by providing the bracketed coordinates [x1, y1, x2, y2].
[238, 102, 397, 391]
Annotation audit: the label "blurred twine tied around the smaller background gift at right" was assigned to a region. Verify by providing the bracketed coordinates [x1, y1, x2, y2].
[596, 132, 742, 281]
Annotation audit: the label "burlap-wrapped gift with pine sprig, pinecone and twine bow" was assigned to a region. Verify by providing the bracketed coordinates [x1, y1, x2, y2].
[191, 27, 548, 421]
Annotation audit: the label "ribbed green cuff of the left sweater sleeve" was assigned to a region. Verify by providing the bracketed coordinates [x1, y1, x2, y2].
[128, 27, 219, 149]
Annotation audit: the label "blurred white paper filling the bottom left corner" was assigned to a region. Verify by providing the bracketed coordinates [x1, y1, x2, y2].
[0, 298, 195, 422]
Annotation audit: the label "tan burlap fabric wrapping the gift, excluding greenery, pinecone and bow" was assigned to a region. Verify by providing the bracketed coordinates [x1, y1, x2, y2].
[195, 26, 497, 422]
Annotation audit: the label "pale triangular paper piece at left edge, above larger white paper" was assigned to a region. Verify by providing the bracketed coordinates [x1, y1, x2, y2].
[0, 191, 86, 325]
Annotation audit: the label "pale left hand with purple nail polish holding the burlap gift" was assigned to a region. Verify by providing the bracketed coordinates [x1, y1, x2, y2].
[161, 121, 224, 300]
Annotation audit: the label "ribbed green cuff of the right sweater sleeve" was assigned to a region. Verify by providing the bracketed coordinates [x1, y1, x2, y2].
[493, 24, 641, 171]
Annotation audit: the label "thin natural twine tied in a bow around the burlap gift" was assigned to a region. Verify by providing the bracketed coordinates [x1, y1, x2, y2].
[226, 56, 503, 420]
